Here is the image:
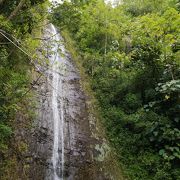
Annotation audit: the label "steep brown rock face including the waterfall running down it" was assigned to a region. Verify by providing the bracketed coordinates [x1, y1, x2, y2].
[29, 25, 122, 180]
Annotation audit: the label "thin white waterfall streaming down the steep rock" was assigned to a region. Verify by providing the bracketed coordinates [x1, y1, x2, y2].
[50, 25, 64, 180]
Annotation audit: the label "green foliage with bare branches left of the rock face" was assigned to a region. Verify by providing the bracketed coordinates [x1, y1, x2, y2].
[0, 0, 46, 176]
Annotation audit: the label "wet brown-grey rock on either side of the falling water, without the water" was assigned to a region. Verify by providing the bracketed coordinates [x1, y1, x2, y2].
[27, 23, 122, 180]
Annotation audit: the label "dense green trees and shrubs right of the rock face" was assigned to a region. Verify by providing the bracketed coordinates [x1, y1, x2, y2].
[53, 0, 180, 180]
